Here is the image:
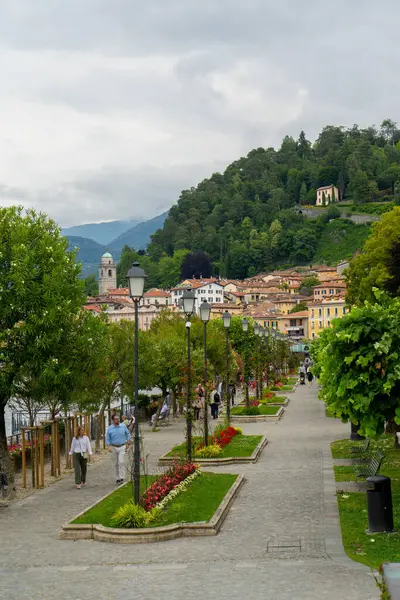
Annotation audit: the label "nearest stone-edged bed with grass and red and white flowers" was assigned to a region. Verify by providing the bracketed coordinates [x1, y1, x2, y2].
[67, 469, 244, 543]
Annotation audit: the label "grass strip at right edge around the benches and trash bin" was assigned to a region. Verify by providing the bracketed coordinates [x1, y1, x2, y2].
[331, 435, 400, 568]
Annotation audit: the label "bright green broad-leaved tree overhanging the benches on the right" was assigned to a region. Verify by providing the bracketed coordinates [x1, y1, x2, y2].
[311, 292, 400, 437]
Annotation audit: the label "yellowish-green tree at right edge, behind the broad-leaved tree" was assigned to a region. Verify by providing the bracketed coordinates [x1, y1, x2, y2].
[346, 206, 400, 305]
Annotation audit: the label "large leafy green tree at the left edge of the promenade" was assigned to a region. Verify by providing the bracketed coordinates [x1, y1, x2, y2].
[0, 207, 87, 489]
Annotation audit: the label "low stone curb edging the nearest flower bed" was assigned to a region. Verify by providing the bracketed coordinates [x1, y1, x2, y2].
[59, 475, 245, 544]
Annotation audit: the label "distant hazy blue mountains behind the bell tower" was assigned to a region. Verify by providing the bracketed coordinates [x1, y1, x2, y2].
[62, 212, 168, 277]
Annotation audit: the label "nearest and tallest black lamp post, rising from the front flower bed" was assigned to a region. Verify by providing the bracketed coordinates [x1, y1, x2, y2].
[126, 262, 147, 505]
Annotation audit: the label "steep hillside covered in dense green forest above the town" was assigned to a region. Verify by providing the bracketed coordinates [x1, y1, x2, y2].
[145, 120, 400, 280]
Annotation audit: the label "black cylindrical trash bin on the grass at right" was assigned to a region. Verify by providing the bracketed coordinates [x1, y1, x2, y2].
[367, 475, 394, 533]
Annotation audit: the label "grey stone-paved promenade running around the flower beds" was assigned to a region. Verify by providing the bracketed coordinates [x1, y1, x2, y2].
[0, 386, 379, 600]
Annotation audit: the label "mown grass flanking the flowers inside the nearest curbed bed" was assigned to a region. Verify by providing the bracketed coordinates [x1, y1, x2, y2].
[73, 473, 238, 527]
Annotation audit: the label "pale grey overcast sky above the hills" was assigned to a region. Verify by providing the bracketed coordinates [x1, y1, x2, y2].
[0, 0, 400, 226]
